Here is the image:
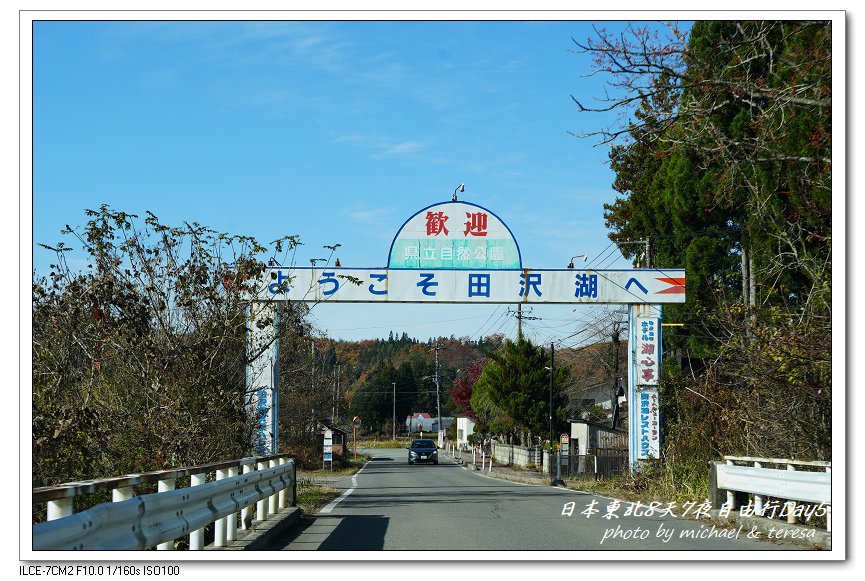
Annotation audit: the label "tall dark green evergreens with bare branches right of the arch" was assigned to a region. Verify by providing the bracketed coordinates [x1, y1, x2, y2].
[577, 21, 832, 480]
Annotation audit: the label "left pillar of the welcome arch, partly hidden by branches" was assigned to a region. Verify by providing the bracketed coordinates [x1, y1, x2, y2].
[246, 302, 279, 456]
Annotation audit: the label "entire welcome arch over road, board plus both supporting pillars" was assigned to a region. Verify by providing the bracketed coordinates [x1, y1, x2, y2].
[247, 200, 685, 464]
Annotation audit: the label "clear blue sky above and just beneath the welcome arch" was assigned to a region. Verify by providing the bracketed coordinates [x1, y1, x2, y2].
[33, 21, 672, 344]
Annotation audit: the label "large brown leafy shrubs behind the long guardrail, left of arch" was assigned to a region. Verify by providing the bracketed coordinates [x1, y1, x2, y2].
[32, 206, 303, 486]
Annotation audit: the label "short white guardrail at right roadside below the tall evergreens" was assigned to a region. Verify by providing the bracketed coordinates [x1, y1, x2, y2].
[710, 456, 832, 532]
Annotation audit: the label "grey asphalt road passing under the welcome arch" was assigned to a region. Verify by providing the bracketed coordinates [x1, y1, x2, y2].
[266, 449, 798, 552]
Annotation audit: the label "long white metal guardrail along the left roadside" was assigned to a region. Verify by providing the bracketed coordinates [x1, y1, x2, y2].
[33, 455, 297, 550]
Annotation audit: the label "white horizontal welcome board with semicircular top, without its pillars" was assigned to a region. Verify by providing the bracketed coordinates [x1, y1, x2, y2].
[258, 202, 685, 304]
